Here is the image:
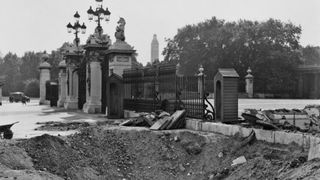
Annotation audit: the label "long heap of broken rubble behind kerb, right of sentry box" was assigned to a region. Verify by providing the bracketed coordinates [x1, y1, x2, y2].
[238, 105, 320, 132]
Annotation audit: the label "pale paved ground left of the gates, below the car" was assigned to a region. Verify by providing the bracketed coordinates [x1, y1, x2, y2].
[0, 100, 101, 138]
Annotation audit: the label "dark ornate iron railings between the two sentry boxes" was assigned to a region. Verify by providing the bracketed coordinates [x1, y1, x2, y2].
[123, 65, 214, 120]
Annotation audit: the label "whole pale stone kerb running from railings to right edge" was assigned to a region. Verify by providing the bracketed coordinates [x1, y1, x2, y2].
[186, 119, 320, 160]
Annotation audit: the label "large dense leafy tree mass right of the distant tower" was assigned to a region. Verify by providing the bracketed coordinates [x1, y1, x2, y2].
[163, 17, 301, 93]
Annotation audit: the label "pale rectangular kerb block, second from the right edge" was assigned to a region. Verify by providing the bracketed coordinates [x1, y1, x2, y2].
[274, 131, 304, 147]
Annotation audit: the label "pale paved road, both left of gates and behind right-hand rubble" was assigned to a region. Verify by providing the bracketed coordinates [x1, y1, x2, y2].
[0, 99, 320, 138]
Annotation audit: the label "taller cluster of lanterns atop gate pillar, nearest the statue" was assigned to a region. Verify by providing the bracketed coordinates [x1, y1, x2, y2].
[87, 0, 111, 36]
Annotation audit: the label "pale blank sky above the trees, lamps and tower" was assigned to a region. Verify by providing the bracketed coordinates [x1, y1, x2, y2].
[0, 0, 320, 64]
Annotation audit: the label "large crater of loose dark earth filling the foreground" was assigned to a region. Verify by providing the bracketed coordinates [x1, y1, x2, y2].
[15, 128, 312, 180]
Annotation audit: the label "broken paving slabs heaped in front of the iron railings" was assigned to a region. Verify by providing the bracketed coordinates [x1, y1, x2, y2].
[120, 110, 186, 130]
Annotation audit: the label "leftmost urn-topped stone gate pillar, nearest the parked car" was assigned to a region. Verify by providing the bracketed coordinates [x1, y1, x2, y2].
[39, 53, 51, 105]
